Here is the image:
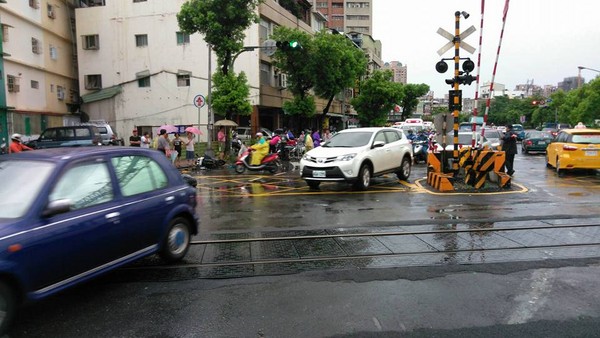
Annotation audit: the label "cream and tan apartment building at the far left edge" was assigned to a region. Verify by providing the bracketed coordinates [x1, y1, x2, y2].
[0, 0, 79, 139]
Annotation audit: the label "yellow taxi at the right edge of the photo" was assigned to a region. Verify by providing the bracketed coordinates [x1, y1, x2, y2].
[546, 128, 600, 175]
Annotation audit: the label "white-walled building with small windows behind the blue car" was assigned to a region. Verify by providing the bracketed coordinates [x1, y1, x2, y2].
[75, 0, 214, 139]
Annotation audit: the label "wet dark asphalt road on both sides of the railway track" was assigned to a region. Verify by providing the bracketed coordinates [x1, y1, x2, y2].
[10, 155, 600, 337]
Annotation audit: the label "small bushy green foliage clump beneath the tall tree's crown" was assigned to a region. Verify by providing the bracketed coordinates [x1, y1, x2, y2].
[211, 72, 252, 119]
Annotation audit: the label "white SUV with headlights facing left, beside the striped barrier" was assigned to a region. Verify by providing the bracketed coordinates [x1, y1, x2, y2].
[300, 128, 413, 190]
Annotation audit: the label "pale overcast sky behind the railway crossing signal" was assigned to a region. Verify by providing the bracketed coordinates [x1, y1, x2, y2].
[373, 0, 600, 98]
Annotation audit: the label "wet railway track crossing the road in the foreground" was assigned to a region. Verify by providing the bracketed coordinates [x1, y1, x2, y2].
[117, 218, 600, 278]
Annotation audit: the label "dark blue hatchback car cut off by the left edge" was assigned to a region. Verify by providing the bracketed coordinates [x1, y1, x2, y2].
[0, 147, 198, 335]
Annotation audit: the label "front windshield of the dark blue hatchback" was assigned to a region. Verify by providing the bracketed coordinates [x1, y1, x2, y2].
[0, 160, 54, 218]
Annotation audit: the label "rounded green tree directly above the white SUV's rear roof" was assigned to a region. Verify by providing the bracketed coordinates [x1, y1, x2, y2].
[350, 70, 404, 126]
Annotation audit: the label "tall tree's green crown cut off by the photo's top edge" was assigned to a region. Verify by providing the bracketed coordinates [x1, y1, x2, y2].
[177, 0, 262, 74]
